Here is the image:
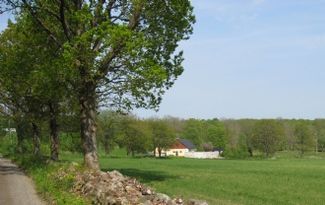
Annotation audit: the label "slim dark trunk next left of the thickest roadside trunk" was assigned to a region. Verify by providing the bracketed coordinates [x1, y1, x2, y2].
[49, 103, 60, 161]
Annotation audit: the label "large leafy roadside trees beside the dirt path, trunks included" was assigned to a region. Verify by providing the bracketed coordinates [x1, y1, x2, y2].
[0, 0, 195, 169]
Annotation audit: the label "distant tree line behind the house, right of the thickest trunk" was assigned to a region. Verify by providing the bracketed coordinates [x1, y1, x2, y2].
[95, 112, 325, 158]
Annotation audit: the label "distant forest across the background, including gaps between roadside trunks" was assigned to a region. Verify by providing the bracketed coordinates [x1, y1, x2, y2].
[0, 110, 325, 159]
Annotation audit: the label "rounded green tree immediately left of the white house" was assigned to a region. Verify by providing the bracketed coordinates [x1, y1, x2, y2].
[149, 119, 176, 157]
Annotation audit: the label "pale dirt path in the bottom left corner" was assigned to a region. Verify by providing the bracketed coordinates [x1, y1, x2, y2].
[0, 157, 44, 205]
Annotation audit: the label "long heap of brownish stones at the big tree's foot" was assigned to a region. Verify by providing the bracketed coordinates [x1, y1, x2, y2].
[72, 168, 208, 205]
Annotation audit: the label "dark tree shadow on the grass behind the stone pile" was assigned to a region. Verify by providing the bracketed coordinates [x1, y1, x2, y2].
[102, 169, 178, 183]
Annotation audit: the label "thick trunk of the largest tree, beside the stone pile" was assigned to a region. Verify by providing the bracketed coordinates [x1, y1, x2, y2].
[79, 80, 99, 170]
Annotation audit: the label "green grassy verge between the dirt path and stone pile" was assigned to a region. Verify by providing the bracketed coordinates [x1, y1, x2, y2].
[0, 137, 90, 205]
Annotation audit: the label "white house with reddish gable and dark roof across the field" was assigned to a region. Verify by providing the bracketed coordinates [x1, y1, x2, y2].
[155, 138, 196, 157]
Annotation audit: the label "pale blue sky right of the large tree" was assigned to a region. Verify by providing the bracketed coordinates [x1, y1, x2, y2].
[0, 0, 325, 119]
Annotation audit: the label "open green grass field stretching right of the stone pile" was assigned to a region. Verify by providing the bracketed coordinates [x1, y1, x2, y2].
[64, 151, 325, 205]
